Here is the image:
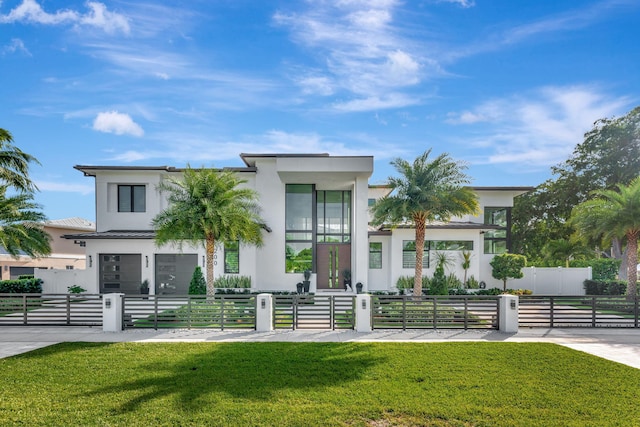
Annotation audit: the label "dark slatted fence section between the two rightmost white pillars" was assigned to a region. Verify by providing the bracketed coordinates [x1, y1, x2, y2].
[371, 295, 499, 330]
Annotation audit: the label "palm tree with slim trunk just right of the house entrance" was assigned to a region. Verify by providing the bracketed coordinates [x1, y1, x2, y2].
[372, 149, 478, 296]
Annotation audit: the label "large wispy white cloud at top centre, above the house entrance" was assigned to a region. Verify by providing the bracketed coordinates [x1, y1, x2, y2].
[273, 0, 428, 111]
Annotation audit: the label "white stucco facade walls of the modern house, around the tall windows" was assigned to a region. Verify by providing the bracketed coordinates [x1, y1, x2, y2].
[68, 154, 527, 294]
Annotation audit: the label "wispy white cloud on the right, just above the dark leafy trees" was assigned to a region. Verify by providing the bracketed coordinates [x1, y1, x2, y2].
[447, 86, 630, 167]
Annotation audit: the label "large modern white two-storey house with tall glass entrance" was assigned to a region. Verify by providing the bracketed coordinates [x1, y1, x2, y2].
[65, 154, 530, 294]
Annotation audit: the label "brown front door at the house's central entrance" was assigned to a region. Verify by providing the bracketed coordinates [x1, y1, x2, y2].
[316, 243, 351, 290]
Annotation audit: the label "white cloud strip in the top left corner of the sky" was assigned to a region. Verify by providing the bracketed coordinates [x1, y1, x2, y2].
[0, 0, 129, 34]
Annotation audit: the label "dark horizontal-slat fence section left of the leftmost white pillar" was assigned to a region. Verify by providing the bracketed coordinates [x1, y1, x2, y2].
[0, 294, 102, 326]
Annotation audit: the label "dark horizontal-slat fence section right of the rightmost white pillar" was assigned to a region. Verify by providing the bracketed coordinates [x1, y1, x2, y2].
[518, 295, 639, 328]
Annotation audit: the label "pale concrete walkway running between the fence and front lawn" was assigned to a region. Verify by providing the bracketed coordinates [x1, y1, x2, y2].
[0, 326, 640, 369]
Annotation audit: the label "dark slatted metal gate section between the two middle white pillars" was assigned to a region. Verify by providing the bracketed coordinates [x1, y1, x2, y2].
[273, 295, 355, 330]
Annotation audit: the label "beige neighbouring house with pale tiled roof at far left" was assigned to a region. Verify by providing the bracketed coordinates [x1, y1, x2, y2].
[0, 218, 96, 280]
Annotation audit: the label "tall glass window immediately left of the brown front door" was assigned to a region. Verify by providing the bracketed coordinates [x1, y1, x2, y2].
[285, 184, 314, 273]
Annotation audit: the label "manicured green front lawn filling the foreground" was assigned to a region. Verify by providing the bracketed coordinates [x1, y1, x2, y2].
[0, 342, 640, 427]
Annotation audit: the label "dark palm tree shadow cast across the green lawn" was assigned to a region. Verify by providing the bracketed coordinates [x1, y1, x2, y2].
[74, 343, 385, 412]
